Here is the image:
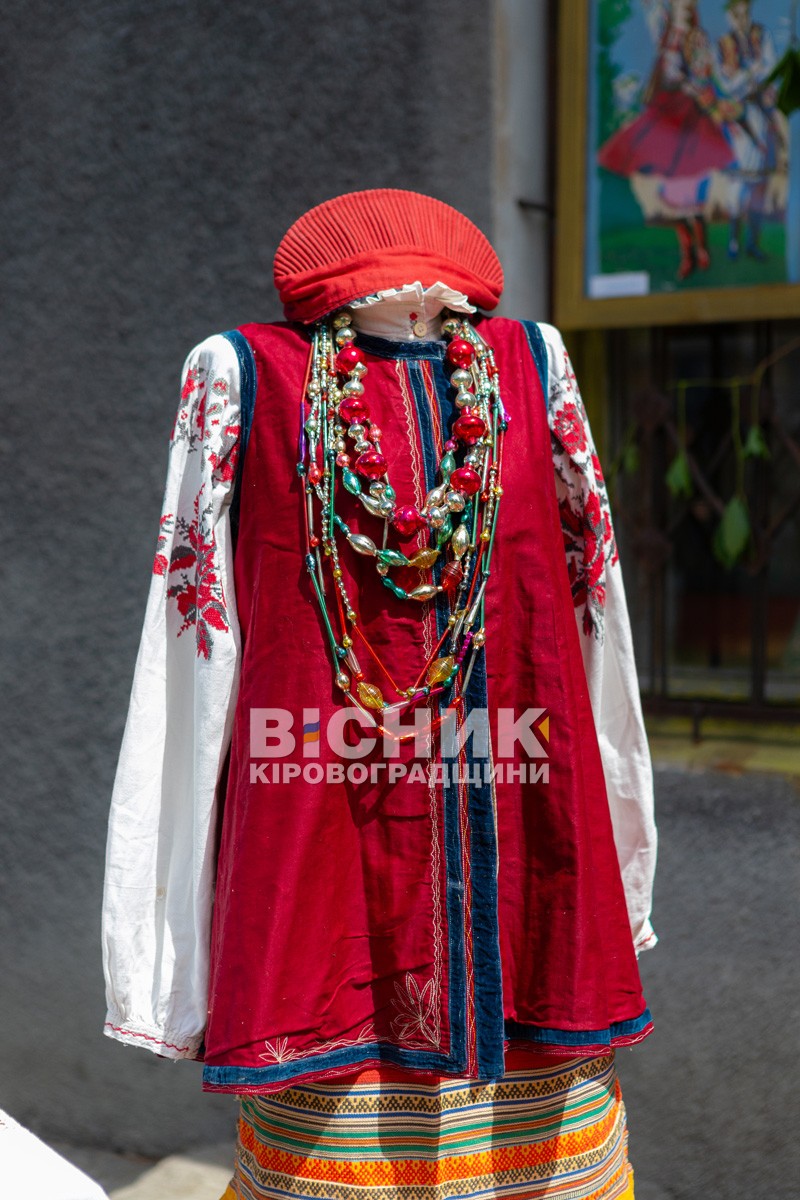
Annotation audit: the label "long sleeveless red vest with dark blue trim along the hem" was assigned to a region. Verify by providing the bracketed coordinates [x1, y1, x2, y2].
[204, 318, 651, 1092]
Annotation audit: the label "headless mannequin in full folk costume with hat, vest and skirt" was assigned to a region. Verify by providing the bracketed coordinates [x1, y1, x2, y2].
[104, 191, 655, 1198]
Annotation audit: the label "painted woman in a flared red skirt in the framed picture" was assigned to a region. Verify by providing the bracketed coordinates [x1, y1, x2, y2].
[597, 0, 739, 280]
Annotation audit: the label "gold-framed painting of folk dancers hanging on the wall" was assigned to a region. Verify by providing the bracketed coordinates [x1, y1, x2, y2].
[555, 0, 800, 329]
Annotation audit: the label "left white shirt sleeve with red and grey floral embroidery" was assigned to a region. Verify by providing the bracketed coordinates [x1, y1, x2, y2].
[102, 336, 240, 1058]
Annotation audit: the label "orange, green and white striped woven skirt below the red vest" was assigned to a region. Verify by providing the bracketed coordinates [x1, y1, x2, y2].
[223, 1052, 633, 1200]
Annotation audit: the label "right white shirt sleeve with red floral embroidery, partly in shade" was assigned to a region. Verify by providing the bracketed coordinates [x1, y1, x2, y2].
[540, 325, 657, 954]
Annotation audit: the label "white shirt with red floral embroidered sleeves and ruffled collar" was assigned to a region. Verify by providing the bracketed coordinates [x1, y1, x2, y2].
[102, 316, 656, 1058]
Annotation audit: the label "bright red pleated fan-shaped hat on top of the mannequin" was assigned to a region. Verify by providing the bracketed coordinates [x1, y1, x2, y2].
[273, 187, 503, 323]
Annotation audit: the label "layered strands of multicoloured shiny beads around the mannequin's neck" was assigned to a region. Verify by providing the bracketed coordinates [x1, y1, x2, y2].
[297, 311, 509, 732]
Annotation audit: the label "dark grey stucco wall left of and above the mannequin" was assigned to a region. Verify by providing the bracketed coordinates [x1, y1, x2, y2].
[0, 0, 492, 1154]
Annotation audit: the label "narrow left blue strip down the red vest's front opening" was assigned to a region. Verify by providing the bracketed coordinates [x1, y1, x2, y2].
[407, 361, 467, 1072]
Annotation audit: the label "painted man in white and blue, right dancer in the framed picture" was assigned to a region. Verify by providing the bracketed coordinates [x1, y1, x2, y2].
[717, 0, 786, 262]
